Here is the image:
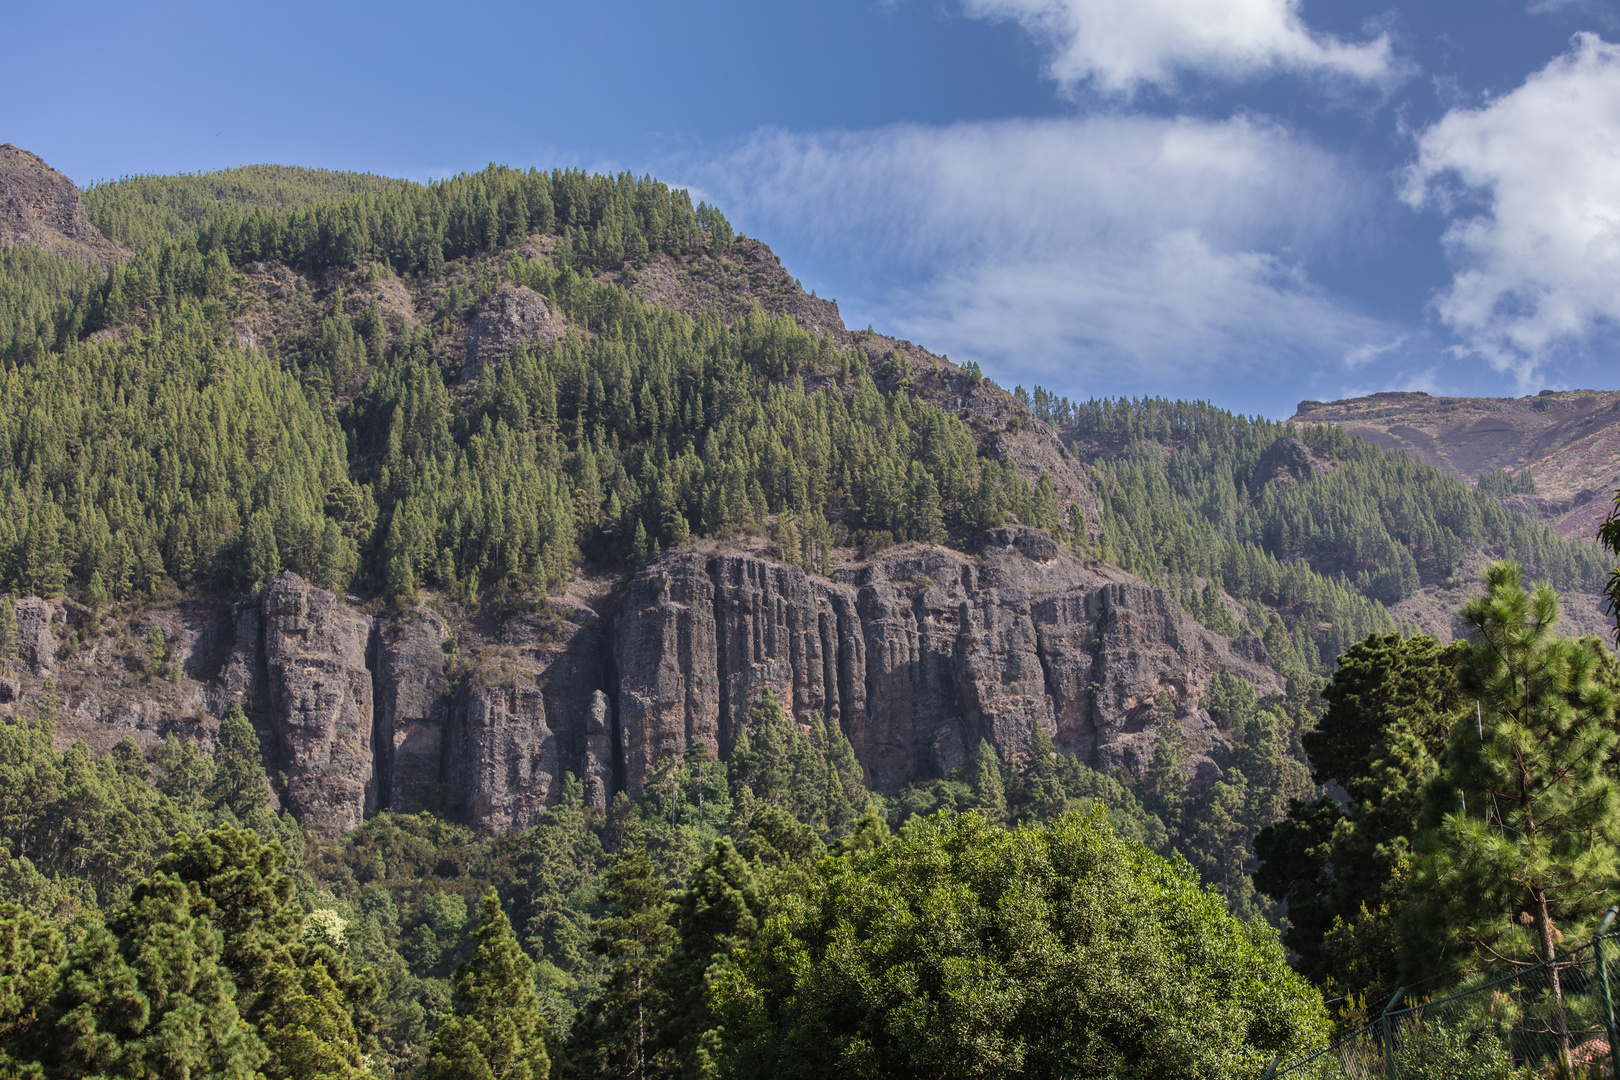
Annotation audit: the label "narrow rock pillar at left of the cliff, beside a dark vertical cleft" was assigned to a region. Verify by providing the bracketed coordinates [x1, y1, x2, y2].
[264, 573, 376, 834]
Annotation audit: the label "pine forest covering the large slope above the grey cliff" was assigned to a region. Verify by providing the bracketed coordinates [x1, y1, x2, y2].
[0, 170, 1059, 602]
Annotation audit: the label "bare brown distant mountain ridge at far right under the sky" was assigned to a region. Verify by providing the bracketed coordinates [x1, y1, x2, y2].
[1293, 390, 1620, 542]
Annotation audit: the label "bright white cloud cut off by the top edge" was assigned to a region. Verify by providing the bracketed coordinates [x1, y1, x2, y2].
[966, 0, 1405, 94]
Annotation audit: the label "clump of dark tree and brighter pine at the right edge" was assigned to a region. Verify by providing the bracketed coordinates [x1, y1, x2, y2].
[1256, 563, 1620, 1022]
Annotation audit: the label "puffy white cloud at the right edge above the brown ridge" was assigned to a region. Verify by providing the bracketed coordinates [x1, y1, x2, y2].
[1403, 34, 1620, 390]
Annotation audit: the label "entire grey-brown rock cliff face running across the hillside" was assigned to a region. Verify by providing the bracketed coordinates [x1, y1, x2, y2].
[0, 528, 1280, 832]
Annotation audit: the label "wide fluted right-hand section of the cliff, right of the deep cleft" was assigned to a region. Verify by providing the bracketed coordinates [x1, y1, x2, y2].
[616, 528, 1278, 790]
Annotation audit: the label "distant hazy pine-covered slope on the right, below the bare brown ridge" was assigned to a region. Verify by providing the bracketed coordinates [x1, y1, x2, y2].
[1056, 387, 1605, 670]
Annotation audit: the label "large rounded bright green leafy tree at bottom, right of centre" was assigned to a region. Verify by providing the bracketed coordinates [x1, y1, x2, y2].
[716, 813, 1325, 1077]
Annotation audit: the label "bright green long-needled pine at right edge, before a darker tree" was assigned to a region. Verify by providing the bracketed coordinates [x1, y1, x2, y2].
[1403, 563, 1620, 972]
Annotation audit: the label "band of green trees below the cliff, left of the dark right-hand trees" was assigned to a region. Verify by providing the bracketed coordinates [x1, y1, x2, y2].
[0, 698, 1324, 1077]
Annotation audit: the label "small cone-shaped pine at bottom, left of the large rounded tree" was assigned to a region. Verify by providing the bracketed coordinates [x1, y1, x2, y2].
[421, 889, 551, 1080]
